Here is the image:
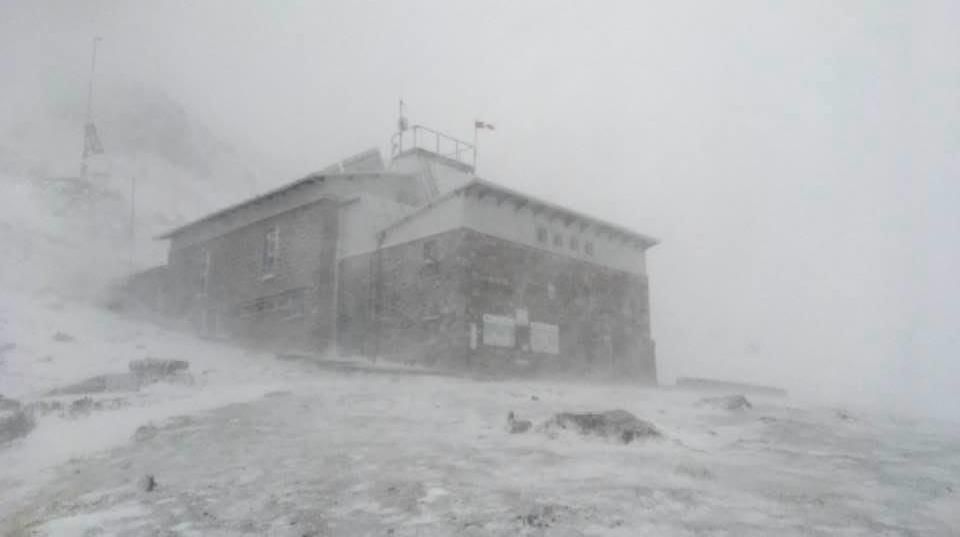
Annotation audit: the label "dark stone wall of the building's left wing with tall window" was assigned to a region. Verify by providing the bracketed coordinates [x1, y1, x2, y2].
[167, 199, 337, 349]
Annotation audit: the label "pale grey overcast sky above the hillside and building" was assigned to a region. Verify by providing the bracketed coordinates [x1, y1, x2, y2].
[0, 0, 960, 415]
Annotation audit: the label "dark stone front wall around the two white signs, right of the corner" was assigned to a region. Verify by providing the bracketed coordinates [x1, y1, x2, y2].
[461, 231, 656, 382]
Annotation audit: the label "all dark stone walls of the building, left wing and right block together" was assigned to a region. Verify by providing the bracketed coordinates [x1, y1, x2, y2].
[163, 199, 656, 382]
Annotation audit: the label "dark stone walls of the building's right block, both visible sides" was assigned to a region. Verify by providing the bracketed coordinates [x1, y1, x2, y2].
[338, 229, 656, 382]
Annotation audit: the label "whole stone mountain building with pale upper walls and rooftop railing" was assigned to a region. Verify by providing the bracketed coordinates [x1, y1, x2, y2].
[161, 127, 657, 382]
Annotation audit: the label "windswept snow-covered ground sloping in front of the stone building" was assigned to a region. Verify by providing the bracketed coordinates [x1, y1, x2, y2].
[0, 293, 960, 536]
